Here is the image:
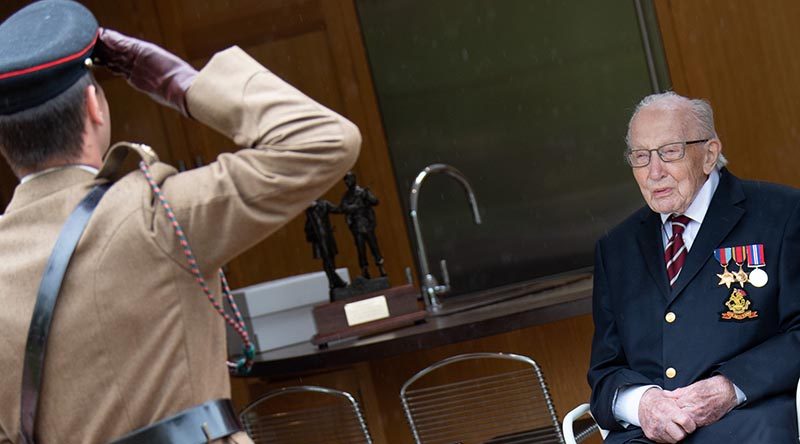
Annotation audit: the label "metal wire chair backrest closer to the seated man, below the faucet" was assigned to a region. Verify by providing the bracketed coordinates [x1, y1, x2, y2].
[400, 353, 564, 444]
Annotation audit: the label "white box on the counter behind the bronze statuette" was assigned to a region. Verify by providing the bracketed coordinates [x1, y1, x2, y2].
[228, 268, 350, 355]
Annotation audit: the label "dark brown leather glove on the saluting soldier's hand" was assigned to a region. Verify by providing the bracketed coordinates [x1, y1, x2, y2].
[93, 29, 197, 117]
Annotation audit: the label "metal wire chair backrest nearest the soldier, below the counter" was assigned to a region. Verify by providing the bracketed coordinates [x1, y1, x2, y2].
[239, 385, 372, 444]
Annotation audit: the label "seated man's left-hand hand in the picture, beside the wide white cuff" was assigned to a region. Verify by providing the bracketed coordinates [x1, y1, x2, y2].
[639, 387, 697, 443]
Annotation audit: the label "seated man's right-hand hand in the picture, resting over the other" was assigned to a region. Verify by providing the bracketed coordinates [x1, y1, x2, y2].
[664, 375, 737, 427]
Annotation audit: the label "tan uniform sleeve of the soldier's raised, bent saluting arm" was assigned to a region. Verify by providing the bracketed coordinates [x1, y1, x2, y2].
[151, 47, 361, 273]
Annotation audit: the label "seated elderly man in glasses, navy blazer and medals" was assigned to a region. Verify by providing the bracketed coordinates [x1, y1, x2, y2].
[588, 93, 800, 443]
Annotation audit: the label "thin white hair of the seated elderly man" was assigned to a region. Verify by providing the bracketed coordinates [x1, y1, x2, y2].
[625, 91, 728, 169]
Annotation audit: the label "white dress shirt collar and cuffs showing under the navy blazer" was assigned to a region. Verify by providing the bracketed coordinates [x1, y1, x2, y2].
[612, 169, 747, 427]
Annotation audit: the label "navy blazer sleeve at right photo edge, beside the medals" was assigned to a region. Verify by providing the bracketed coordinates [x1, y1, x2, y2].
[716, 198, 800, 403]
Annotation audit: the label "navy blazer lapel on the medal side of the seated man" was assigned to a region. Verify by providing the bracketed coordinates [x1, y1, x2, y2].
[665, 169, 745, 302]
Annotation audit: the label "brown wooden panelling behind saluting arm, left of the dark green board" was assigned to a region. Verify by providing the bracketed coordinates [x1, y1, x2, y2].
[142, 0, 413, 286]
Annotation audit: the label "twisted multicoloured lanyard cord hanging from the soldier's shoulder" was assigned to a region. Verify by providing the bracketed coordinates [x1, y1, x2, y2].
[139, 162, 255, 376]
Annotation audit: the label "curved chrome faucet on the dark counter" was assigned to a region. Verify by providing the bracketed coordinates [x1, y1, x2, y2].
[409, 163, 481, 312]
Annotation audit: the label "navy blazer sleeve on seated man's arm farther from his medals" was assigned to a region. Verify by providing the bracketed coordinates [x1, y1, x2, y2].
[588, 242, 653, 430]
